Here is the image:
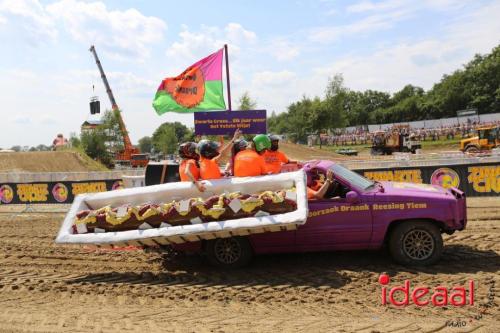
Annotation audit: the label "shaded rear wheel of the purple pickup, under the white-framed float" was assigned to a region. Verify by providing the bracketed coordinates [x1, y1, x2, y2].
[205, 237, 253, 268]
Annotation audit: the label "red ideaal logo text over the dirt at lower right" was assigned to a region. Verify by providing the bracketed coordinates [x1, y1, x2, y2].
[378, 274, 474, 307]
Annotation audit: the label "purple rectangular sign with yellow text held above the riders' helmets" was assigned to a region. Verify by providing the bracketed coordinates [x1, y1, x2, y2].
[194, 110, 267, 135]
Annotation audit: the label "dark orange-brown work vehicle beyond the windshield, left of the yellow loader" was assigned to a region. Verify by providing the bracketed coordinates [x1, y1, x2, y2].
[371, 125, 422, 155]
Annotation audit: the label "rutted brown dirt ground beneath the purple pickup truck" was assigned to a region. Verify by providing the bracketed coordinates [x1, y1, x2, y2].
[0, 198, 500, 333]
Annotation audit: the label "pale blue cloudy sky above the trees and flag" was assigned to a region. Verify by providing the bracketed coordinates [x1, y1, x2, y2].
[0, 0, 500, 148]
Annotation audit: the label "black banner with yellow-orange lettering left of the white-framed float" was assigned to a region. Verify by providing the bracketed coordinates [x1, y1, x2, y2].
[0, 179, 123, 205]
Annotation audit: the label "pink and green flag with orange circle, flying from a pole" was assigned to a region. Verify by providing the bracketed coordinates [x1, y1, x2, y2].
[153, 49, 226, 115]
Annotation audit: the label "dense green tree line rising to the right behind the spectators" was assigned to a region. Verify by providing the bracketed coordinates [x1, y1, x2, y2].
[268, 45, 500, 142]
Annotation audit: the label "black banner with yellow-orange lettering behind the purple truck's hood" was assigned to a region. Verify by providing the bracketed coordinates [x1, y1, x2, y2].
[354, 163, 500, 197]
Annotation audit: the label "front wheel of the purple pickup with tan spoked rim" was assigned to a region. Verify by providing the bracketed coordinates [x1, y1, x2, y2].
[389, 221, 443, 266]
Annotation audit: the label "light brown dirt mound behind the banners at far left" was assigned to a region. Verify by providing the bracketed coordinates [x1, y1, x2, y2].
[0, 151, 107, 172]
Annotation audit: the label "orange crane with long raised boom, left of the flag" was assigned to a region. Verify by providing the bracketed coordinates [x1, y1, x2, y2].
[89, 45, 149, 167]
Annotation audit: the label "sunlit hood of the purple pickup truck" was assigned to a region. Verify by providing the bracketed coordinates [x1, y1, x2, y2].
[380, 182, 454, 199]
